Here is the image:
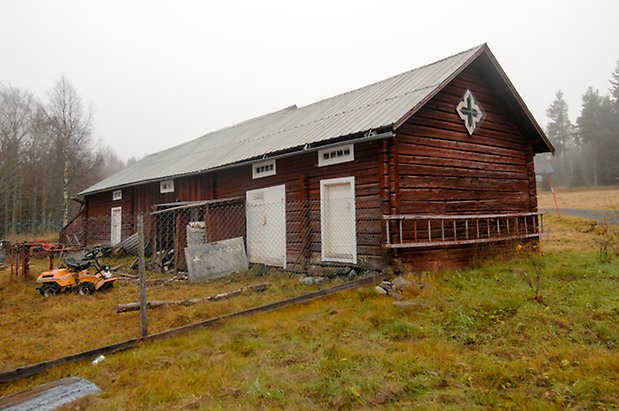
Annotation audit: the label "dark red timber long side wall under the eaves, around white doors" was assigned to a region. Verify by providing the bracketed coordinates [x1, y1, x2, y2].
[86, 140, 393, 265]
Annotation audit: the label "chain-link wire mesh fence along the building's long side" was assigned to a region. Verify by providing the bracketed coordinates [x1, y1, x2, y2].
[61, 197, 385, 275]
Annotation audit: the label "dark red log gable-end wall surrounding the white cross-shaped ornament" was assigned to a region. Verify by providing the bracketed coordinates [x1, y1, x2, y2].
[392, 64, 537, 270]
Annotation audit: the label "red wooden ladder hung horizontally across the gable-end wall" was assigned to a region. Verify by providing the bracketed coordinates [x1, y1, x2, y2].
[383, 213, 544, 248]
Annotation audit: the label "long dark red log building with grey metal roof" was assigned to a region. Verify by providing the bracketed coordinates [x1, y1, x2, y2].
[70, 44, 554, 269]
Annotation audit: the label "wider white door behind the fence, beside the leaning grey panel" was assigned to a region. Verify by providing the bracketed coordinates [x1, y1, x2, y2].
[245, 185, 286, 268]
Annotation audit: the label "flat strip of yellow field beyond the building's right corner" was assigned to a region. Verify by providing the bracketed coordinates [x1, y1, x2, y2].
[537, 186, 619, 210]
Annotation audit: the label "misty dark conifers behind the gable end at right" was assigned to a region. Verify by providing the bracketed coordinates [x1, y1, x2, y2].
[546, 61, 619, 187]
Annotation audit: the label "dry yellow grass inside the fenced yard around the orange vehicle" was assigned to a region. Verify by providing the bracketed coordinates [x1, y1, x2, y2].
[0, 261, 336, 371]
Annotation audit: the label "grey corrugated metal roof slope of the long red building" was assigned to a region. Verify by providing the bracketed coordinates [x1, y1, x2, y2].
[78, 45, 487, 195]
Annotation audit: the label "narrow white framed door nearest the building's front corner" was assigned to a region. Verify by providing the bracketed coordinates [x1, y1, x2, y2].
[320, 177, 357, 264]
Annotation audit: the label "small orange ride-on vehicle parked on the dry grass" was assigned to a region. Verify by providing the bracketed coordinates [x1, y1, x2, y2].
[37, 248, 116, 297]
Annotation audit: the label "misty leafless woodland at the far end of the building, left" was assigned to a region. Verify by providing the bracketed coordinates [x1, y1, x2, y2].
[0, 76, 125, 238]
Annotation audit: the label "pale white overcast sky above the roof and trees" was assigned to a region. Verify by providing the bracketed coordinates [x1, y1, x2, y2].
[0, 0, 619, 159]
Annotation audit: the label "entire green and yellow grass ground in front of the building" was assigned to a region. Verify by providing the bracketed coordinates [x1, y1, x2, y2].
[0, 191, 619, 410]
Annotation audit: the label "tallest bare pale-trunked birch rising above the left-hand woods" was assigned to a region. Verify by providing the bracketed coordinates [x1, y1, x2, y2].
[47, 76, 92, 225]
